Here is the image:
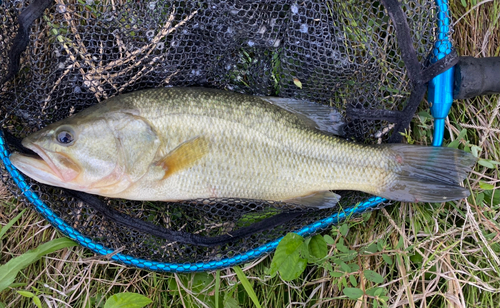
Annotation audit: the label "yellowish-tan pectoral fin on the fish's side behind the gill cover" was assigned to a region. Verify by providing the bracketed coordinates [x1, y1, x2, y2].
[157, 137, 208, 180]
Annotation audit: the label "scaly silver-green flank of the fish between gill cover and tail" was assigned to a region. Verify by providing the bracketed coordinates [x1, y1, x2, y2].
[125, 90, 394, 200]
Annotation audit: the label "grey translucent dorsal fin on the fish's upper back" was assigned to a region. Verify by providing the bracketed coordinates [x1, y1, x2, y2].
[262, 96, 345, 136]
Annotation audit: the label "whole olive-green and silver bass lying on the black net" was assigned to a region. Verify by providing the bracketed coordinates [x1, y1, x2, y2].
[10, 87, 476, 208]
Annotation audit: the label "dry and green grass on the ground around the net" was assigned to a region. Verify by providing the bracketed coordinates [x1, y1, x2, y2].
[0, 0, 500, 308]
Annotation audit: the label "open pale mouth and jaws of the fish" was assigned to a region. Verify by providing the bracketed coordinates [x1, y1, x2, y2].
[10, 144, 80, 186]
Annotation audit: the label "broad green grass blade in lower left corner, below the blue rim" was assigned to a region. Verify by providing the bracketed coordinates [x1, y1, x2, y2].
[0, 237, 77, 292]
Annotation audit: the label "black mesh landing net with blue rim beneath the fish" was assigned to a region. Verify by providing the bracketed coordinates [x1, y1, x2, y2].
[0, 0, 455, 272]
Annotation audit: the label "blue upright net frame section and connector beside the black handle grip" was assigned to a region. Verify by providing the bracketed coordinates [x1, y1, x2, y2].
[427, 0, 455, 146]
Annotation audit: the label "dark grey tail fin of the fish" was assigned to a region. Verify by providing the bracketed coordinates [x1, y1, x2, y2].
[378, 144, 476, 202]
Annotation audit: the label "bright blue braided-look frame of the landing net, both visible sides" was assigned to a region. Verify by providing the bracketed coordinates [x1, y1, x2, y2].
[0, 0, 453, 273]
